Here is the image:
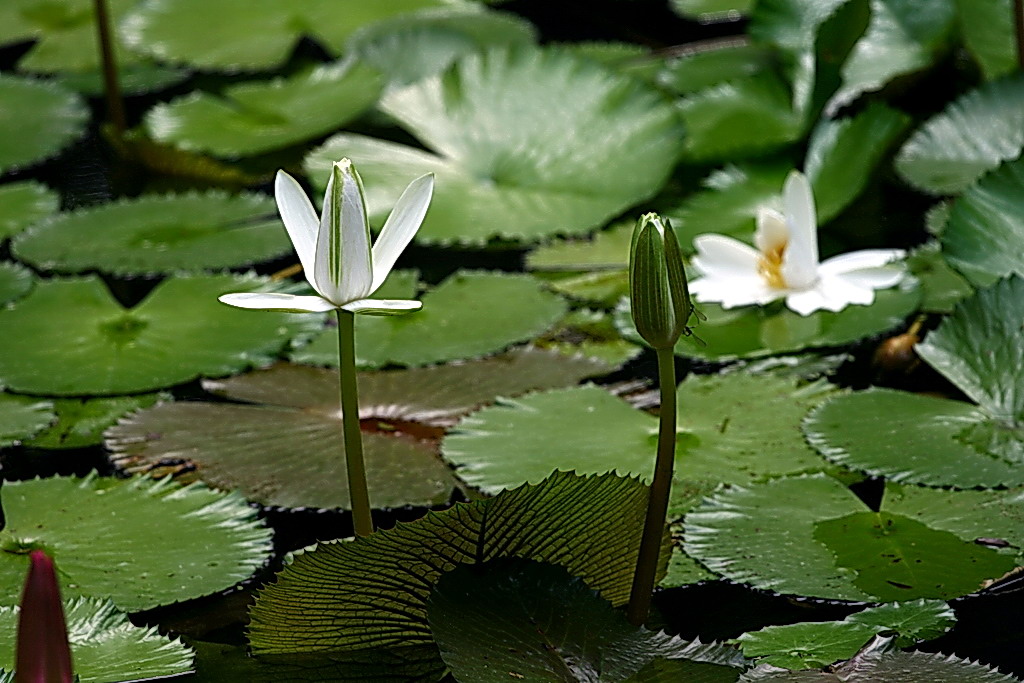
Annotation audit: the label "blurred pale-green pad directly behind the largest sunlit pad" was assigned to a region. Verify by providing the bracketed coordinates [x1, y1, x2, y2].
[345, 5, 536, 87]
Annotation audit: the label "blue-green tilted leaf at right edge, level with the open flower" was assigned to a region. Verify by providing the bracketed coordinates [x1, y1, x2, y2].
[941, 160, 1024, 285]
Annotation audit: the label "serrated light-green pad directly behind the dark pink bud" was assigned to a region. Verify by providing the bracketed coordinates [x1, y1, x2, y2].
[0, 475, 271, 611]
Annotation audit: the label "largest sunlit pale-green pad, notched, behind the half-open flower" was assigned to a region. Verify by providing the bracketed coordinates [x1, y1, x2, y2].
[306, 47, 683, 245]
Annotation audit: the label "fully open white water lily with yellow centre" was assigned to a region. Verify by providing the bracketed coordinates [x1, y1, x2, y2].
[689, 171, 905, 315]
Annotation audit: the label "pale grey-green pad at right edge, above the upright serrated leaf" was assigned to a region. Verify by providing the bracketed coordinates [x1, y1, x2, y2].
[896, 75, 1024, 195]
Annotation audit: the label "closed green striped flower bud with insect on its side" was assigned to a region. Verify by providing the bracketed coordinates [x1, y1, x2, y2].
[630, 213, 694, 349]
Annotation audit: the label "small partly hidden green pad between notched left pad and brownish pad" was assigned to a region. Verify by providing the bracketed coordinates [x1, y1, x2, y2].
[26, 393, 163, 449]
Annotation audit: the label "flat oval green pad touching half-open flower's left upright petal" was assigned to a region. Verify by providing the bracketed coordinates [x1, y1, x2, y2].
[12, 190, 292, 275]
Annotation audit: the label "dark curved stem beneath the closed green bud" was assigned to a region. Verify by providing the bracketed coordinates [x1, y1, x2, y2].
[626, 347, 676, 626]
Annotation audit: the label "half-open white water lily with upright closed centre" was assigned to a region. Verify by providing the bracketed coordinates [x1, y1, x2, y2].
[220, 159, 434, 315]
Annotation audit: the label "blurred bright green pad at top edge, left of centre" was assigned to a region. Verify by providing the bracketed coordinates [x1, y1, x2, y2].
[122, 0, 460, 71]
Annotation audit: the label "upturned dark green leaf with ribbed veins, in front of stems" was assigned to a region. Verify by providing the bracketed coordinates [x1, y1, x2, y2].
[250, 472, 669, 654]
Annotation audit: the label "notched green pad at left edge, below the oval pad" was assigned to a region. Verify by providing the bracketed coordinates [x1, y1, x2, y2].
[0, 275, 319, 395]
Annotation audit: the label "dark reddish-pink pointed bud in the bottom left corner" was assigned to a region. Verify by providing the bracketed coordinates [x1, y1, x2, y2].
[14, 550, 75, 683]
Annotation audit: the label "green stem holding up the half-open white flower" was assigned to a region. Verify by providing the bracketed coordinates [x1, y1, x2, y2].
[336, 308, 374, 536]
